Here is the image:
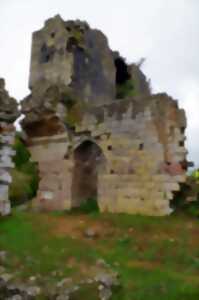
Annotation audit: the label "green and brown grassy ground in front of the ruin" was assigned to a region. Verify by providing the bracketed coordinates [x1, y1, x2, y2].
[0, 211, 199, 300]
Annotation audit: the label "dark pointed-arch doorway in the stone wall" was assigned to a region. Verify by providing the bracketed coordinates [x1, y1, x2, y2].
[72, 140, 105, 207]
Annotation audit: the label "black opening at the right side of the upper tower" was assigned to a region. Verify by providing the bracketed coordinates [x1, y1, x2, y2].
[115, 57, 131, 84]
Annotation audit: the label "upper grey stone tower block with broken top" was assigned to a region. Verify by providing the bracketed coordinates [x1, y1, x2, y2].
[29, 15, 115, 104]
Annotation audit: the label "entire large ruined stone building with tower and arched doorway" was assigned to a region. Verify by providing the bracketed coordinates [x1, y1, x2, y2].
[22, 16, 187, 215]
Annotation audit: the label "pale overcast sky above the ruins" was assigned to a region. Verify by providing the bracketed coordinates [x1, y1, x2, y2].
[0, 0, 199, 165]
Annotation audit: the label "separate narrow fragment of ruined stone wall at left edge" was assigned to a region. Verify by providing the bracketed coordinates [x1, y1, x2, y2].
[0, 78, 19, 216]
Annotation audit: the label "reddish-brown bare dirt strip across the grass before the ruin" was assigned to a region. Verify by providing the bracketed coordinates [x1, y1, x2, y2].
[32, 213, 199, 252]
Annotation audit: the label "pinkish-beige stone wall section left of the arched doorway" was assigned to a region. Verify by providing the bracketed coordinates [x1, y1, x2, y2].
[26, 133, 72, 210]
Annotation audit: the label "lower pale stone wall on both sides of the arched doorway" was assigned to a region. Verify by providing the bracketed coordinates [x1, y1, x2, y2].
[26, 94, 187, 215]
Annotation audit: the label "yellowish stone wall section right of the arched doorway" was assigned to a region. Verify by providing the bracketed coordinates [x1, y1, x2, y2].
[74, 95, 187, 215]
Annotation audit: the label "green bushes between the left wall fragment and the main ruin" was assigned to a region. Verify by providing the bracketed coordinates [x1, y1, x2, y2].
[9, 133, 39, 206]
